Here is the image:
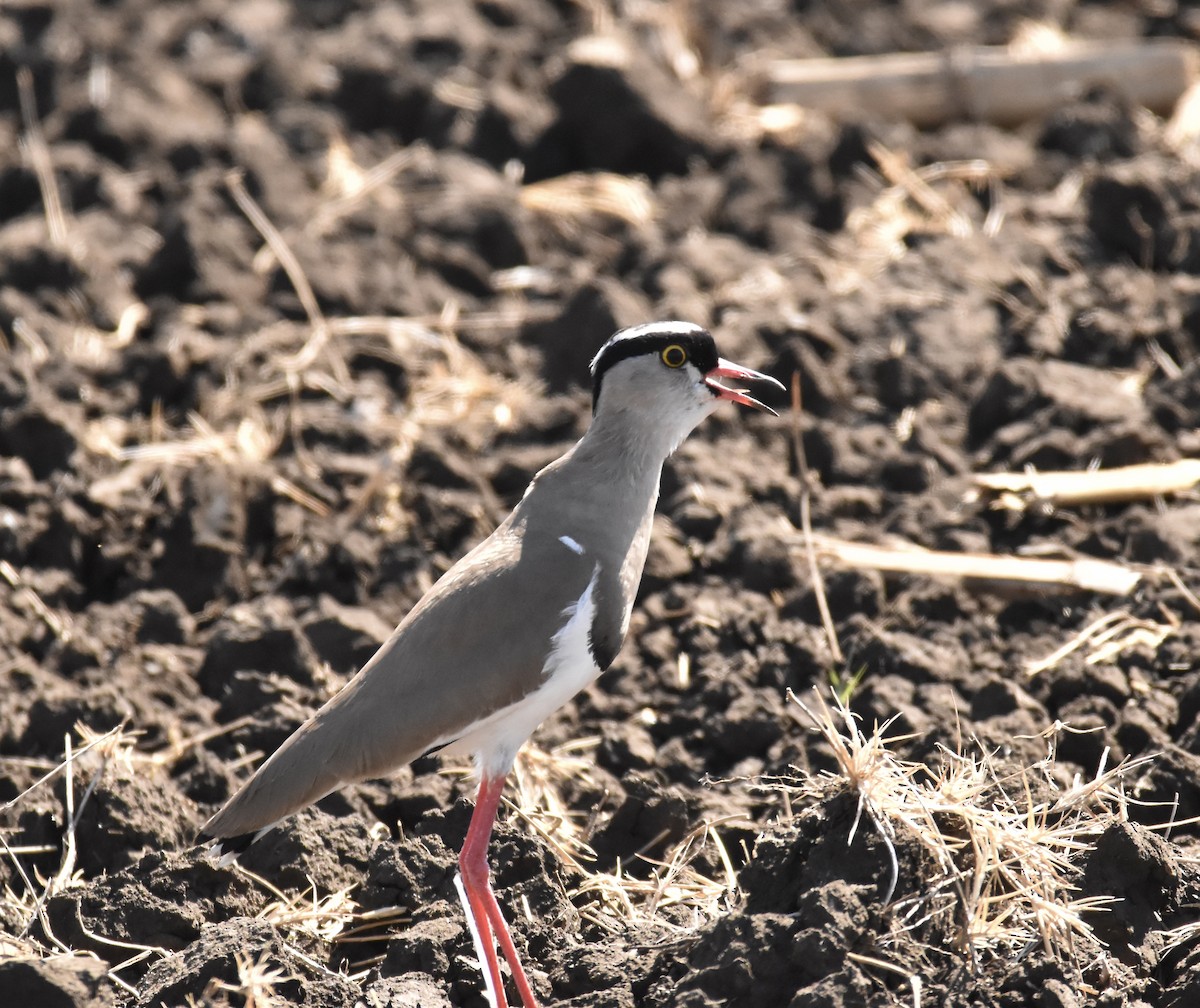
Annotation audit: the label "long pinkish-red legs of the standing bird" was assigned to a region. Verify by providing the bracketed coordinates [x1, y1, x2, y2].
[458, 775, 538, 1008]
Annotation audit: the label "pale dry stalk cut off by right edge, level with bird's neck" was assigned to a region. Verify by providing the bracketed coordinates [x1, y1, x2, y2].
[973, 458, 1200, 511]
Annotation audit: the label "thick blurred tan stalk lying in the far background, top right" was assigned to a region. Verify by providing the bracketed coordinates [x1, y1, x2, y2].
[767, 38, 1200, 127]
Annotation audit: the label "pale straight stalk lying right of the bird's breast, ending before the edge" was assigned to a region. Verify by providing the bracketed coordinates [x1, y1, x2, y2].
[816, 536, 1141, 595]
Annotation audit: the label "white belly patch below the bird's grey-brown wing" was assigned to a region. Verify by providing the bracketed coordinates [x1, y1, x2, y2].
[442, 565, 600, 776]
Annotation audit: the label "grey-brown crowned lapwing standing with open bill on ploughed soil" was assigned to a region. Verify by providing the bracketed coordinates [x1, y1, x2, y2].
[197, 322, 784, 1008]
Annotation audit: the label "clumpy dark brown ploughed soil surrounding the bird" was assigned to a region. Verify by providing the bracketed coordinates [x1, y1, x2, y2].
[0, 0, 1200, 1008]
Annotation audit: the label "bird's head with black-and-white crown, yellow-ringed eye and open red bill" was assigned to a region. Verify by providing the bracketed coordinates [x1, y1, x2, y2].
[592, 322, 784, 446]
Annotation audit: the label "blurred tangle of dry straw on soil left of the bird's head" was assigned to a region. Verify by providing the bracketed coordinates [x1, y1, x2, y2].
[84, 317, 538, 527]
